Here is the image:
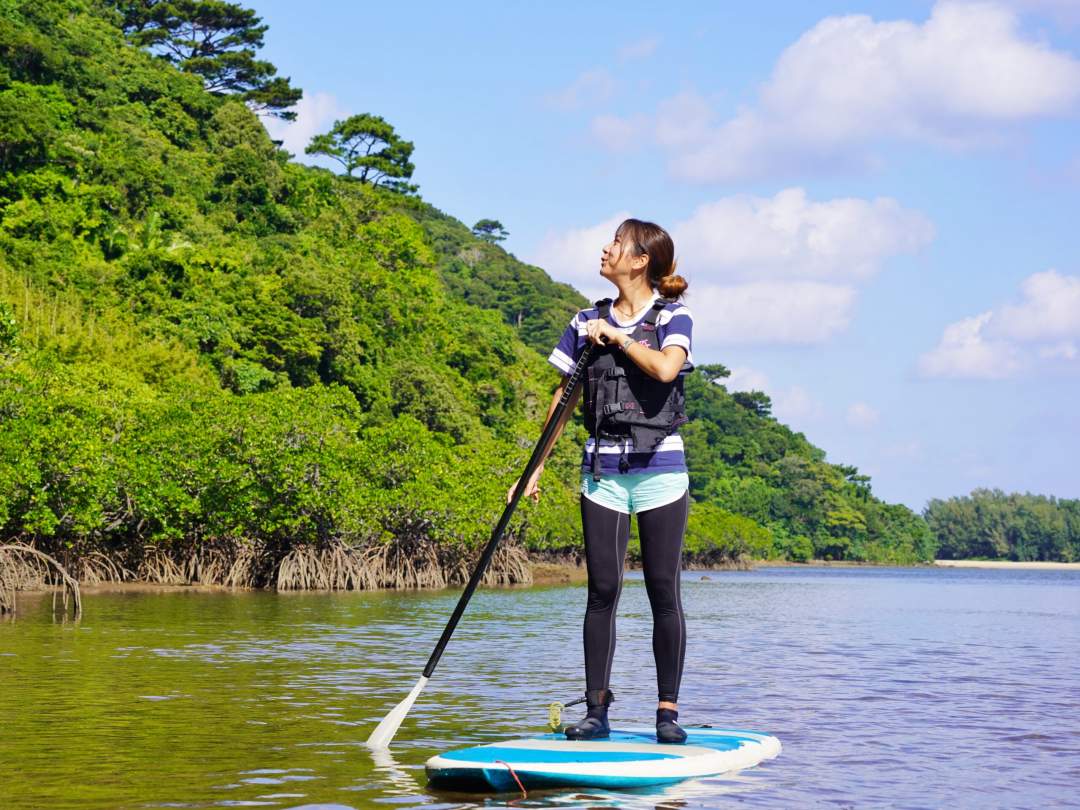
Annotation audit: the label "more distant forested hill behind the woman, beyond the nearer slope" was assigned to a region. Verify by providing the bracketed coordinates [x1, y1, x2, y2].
[403, 200, 934, 563]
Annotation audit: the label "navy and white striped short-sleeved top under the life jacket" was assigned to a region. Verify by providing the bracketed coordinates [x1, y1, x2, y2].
[548, 295, 693, 475]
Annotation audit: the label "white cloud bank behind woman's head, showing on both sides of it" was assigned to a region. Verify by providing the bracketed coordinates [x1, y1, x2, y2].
[529, 188, 933, 347]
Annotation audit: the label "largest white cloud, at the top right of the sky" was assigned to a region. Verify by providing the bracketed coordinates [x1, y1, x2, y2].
[596, 0, 1080, 183]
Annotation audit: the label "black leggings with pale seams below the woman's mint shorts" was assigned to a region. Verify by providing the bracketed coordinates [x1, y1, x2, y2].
[581, 492, 690, 703]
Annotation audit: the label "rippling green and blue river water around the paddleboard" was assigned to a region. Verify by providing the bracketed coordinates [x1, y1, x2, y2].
[0, 567, 1080, 809]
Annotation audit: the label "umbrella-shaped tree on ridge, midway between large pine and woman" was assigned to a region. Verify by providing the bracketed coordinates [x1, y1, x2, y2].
[305, 112, 417, 192]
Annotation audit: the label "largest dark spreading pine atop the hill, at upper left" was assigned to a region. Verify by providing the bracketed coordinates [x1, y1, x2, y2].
[109, 0, 303, 121]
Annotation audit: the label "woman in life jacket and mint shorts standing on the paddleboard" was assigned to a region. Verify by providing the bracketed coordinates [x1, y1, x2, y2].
[508, 219, 693, 743]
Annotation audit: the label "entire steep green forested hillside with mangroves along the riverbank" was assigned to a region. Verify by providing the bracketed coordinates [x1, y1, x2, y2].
[0, 0, 932, 588]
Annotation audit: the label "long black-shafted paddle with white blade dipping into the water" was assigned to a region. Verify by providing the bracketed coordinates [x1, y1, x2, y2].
[367, 342, 595, 750]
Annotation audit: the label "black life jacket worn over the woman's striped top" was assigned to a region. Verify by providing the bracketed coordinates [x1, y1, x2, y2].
[584, 298, 689, 481]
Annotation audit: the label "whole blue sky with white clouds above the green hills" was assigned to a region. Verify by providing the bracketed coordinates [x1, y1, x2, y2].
[251, 0, 1080, 511]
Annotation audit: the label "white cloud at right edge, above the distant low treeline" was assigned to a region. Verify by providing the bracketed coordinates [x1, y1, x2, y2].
[918, 270, 1080, 379]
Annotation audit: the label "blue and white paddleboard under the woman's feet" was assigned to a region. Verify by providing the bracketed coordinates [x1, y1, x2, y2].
[426, 727, 780, 791]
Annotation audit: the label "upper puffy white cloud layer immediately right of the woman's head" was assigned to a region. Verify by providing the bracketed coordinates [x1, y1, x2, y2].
[672, 188, 934, 280]
